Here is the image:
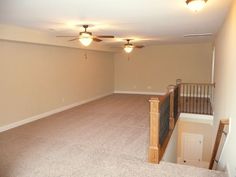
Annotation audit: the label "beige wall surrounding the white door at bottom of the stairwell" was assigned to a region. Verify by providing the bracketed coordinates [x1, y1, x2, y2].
[177, 120, 213, 162]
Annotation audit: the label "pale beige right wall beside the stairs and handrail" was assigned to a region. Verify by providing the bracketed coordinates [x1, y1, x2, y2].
[214, 0, 236, 176]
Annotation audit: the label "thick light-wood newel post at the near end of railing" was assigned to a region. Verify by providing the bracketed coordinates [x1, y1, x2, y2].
[148, 98, 160, 163]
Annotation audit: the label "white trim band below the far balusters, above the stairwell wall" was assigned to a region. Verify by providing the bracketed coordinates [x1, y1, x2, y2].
[179, 113, 213, 125]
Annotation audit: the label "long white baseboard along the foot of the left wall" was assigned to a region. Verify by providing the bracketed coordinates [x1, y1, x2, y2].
[0, 93, 113, 132]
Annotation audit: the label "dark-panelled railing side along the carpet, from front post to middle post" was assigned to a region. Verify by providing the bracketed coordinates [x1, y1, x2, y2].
[148, 86, 177, 163]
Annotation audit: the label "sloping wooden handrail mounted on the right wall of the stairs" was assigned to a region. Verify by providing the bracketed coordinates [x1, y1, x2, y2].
[209, 119, 229, 169]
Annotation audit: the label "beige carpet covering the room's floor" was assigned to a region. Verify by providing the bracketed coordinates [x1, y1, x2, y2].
[0, 94, 224, 177]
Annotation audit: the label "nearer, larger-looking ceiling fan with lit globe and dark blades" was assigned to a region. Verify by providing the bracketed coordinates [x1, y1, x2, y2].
[56, 25, 114, 46]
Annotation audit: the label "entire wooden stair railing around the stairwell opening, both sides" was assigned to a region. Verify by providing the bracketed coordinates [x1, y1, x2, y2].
[148, 79, 215, 163]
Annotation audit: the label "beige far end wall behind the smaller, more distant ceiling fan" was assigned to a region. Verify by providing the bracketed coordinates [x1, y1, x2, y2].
[115, 43, 212, 92]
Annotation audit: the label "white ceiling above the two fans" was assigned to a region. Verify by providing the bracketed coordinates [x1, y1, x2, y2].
[0, 0, 231, 45]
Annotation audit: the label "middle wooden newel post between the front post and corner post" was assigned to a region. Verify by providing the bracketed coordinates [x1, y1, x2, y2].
[168, 85, 175, 130]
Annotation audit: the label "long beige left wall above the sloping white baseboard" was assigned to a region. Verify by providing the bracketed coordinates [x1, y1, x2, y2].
[0, 41, 114, 127]
